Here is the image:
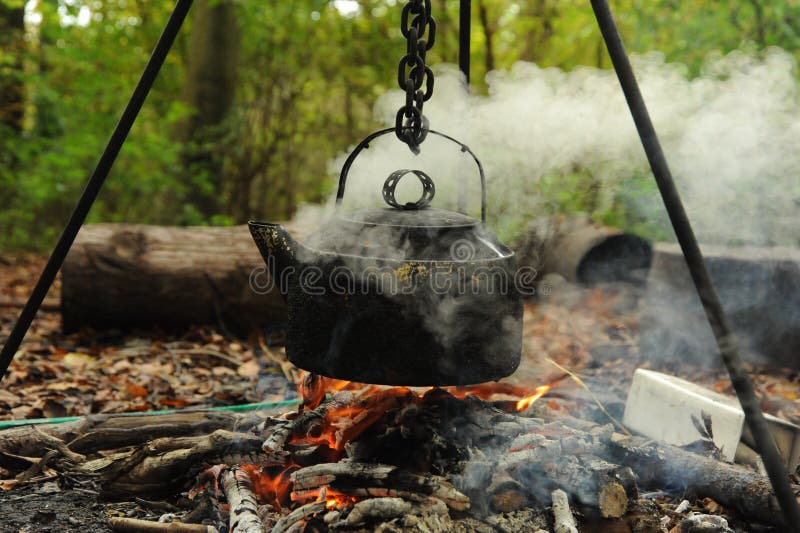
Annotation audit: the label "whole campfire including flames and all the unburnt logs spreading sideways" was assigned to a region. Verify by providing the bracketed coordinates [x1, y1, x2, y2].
[14, 366, 776, 533]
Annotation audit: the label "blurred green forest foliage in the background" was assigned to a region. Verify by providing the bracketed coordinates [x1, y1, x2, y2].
[0, 0, 800, 249]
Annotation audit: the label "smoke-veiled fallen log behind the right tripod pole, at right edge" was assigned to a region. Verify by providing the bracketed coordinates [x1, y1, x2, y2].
[639, 243, 800, 370]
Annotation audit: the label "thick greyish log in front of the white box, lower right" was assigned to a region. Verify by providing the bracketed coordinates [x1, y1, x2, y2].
[609, 434, 800, 524]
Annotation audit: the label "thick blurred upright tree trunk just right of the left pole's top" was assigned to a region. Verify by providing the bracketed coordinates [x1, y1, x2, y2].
[180, 0, 239, 218]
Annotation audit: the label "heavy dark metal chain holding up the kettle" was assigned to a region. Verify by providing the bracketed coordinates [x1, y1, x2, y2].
[395, 0, 436, 153]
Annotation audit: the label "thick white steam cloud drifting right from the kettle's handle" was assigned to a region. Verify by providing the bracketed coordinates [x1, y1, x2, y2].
[332, 48, 800, 245]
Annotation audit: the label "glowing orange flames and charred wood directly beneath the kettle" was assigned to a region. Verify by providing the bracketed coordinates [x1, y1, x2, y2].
[217, 373, 550, 531]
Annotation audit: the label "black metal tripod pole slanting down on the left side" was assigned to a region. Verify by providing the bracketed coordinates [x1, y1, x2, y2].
[0, 0, 192, 380]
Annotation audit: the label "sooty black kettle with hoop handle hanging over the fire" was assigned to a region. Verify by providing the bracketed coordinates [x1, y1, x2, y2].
[249, 128, 524, 386]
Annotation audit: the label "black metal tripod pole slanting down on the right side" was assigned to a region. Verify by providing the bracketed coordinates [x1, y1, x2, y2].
[591, 0, 800, 532]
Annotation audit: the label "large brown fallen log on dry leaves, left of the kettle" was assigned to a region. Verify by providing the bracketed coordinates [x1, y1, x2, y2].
[61, 224, 298, 333]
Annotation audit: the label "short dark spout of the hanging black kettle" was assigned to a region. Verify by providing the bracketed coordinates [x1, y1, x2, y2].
[247, 222, 305, 297]
